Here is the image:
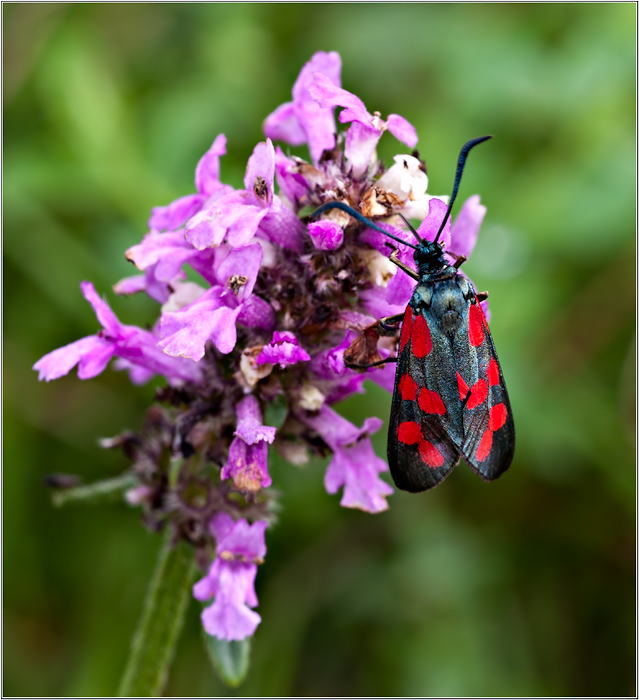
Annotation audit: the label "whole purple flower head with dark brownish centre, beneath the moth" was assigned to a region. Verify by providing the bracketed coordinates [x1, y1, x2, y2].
[34, 47, 485, 640]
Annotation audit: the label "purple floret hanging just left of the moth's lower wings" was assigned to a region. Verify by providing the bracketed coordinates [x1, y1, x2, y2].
[302, 405, 393, 513]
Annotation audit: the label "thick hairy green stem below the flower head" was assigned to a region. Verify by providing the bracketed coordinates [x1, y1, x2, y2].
[118, 528, 196, 697]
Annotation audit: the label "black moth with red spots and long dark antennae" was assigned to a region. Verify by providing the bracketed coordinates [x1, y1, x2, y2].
[311, 136, 515, 492]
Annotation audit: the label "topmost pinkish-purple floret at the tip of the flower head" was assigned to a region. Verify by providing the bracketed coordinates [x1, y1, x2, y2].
[264, 51, 342, 163]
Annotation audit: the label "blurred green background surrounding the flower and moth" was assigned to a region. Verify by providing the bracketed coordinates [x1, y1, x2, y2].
[2, 3, 636, 696]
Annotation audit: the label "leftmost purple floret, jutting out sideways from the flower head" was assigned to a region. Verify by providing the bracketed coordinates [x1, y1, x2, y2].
[33, 282, 202, 384]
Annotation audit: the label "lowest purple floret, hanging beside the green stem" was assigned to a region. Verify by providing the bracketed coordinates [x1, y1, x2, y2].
[193, 513, 266, 641]
